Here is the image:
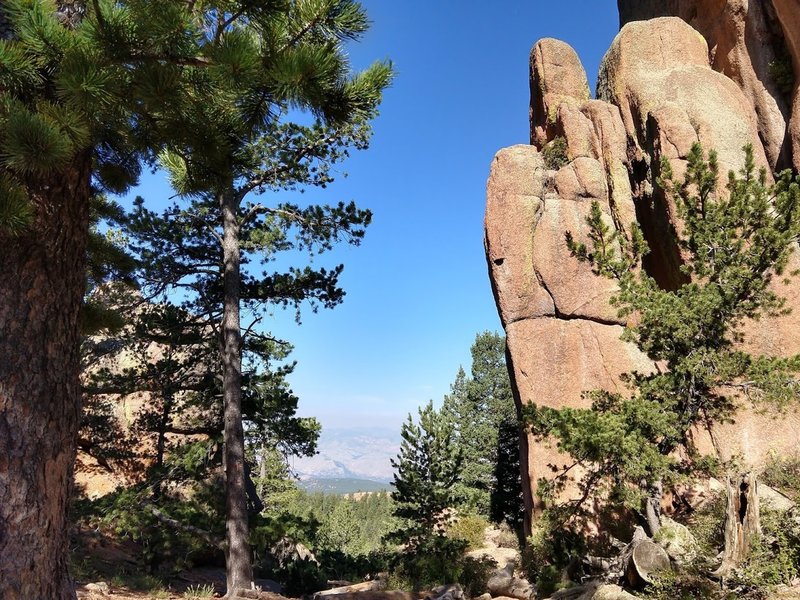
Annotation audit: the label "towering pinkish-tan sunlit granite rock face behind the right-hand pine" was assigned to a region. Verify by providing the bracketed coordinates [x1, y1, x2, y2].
[485, 11, 800, 536]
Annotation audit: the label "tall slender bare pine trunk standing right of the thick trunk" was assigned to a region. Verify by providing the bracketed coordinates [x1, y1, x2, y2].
[220, 192, 253, 597]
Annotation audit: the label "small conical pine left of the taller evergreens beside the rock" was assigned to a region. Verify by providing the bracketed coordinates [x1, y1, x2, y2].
[392, 402, 462, 547]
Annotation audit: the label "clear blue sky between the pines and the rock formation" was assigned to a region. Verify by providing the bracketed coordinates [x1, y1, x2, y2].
[130, 0, 618, 431]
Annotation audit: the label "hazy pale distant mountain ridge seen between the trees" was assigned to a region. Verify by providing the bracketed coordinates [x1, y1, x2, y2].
[292, 428, 400, 482]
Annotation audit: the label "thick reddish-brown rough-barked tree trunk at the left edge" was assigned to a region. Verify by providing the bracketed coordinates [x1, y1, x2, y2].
[0, 152, 91, 600]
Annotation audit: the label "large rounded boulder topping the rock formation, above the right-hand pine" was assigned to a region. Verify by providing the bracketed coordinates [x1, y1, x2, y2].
[597, 17, 767, 178]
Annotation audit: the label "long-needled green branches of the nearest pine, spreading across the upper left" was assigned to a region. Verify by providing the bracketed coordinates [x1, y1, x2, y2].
[0, 0, 391, 233]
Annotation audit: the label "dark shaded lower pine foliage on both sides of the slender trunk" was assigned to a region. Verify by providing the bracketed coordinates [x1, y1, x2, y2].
[79, 287, 319, 568]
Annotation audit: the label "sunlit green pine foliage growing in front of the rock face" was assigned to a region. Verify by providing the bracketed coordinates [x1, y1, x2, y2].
[527, 145, 800, 519]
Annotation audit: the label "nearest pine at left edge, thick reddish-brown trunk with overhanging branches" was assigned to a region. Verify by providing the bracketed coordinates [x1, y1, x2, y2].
[0, 0, 390, 598]
